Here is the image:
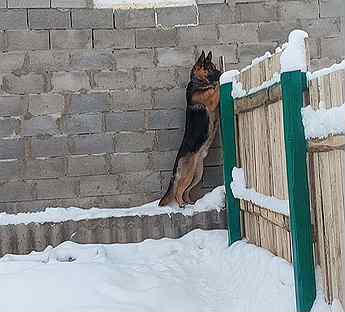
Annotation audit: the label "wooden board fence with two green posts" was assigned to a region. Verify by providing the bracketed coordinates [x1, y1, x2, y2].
[221, 31, 345, 312]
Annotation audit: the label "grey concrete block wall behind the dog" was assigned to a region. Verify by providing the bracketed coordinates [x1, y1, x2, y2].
[0, 0, 345, 213]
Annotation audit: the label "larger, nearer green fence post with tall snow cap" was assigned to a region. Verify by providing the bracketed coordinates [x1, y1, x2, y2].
[281, 71, 316, 312]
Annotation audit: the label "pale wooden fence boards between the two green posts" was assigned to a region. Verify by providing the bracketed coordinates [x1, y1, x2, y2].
[235, 53, 292, 262]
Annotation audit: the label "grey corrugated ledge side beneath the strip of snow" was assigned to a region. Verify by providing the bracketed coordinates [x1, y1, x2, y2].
[0, 209, 226, 256]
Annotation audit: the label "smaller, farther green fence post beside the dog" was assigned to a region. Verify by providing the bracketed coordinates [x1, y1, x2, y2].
[220, 82, 241, 245]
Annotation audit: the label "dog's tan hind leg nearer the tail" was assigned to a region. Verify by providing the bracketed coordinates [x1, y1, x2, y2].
[175, 154, 198, 207]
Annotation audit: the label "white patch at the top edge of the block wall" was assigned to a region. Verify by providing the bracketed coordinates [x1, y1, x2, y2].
[94, 0, 196, 9]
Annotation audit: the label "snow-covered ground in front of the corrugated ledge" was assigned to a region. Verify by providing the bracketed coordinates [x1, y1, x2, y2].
[0, 230, 330, 312]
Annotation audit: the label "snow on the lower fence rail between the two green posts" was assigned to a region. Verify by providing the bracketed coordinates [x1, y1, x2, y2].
[230, 167, 289, 216]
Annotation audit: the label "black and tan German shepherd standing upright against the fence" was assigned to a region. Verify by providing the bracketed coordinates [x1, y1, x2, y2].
[159, 51, 221, 207]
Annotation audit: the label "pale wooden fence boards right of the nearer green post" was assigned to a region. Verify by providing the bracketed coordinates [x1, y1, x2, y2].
[309, 71, 345, 306]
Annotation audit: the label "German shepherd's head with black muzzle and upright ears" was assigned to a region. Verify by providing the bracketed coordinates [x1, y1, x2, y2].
[190, 51, 222, 84]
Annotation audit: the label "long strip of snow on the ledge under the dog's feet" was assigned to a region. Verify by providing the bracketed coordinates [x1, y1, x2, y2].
[0, 186, 225, 225]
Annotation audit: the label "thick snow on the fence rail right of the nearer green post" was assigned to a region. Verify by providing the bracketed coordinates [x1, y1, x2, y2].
[302, 104, 345, 139]
